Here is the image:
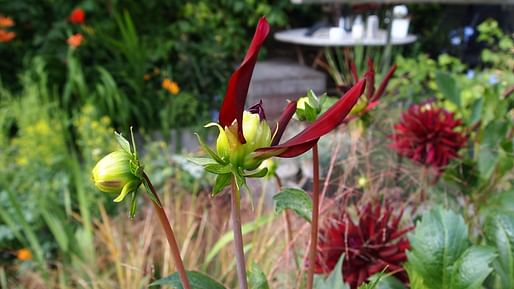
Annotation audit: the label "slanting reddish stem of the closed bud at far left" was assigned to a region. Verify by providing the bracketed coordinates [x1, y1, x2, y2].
[143, 173, 191, 289]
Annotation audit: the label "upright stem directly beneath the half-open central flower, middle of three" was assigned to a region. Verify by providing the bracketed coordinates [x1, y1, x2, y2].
[230, 176, 248, 289]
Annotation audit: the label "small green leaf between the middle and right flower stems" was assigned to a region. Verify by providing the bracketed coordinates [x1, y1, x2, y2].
[273, 188, 312, 222]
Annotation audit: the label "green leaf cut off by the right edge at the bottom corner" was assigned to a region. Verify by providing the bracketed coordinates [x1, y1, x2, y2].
[484, 213, 514, 289]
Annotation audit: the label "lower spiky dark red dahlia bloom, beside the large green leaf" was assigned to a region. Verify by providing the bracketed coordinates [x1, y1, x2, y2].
[314, 204, 413, 289]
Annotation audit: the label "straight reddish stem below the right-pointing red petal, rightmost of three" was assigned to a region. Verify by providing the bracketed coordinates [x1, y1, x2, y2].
[307, 144, 319, 289]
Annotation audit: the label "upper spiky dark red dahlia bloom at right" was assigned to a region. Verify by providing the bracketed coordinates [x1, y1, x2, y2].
[390, 103, 467, 171]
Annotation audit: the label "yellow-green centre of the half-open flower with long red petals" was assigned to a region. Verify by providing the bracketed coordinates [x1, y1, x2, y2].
[212, 111, 271, 170]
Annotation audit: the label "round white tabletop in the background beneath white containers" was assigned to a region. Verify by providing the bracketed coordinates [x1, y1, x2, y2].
[274, 28, 417, 47]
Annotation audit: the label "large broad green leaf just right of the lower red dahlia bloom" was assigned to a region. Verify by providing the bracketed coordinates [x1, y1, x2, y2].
[406, 207, 494, 289]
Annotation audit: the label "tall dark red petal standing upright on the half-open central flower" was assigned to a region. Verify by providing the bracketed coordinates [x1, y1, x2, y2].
[219, 17, 270, 143]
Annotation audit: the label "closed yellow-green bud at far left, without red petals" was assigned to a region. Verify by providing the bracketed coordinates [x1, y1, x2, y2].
[93, 150, 142, 202]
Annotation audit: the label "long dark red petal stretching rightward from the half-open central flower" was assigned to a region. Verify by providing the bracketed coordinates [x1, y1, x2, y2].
[257, 79, 366, 158]
